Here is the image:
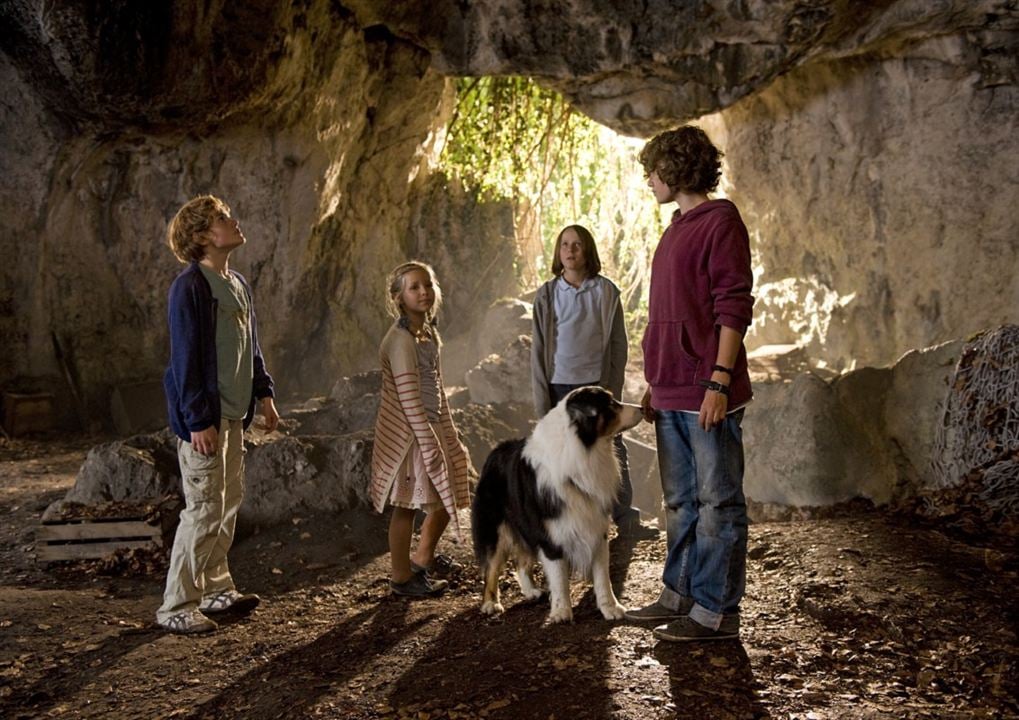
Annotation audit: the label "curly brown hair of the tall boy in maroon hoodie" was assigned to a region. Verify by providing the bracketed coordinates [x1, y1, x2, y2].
[639, 125, 722, 195]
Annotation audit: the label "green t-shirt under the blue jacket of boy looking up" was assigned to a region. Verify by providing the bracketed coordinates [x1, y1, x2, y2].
[199, 265, 255, 420]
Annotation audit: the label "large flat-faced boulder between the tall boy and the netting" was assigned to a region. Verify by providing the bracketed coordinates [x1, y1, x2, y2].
[744, 341, 961, 507]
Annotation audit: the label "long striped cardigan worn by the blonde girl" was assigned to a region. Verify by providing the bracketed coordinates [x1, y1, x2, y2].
[371, 323, 471, 538]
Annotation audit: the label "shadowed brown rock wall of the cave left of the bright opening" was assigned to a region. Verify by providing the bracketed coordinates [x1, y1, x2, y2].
[0, 2, 513, 426]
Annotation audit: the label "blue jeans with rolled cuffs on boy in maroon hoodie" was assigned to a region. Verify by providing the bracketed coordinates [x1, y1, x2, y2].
[654, 409, 747, 629]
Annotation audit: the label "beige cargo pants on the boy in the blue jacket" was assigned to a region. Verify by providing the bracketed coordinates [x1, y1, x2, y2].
[156, 419, 245, 622]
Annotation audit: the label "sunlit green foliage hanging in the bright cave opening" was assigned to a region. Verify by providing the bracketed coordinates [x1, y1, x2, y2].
[439, 77, 667, 348]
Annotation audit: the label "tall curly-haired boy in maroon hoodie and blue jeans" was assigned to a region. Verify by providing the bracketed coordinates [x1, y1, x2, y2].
[627, 125, 754, 641]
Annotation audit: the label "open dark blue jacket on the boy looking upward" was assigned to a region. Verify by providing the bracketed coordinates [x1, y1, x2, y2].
[163, 263, 273, 442]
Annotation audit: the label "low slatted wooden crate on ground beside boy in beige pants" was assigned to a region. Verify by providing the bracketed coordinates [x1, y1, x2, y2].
[36, 518, 163, 562]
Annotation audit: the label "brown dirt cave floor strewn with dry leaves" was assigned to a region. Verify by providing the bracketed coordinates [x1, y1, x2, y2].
[0, 439, 1019, 720]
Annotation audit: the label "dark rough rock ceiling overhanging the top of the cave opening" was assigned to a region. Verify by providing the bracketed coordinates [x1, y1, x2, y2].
[0, 0, 1009, 135]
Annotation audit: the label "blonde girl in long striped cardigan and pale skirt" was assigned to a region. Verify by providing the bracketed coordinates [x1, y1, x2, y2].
[371, 261, 471, 597]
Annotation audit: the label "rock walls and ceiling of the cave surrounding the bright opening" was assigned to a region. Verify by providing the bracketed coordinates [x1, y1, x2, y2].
[0, 0, 1019, 433]
